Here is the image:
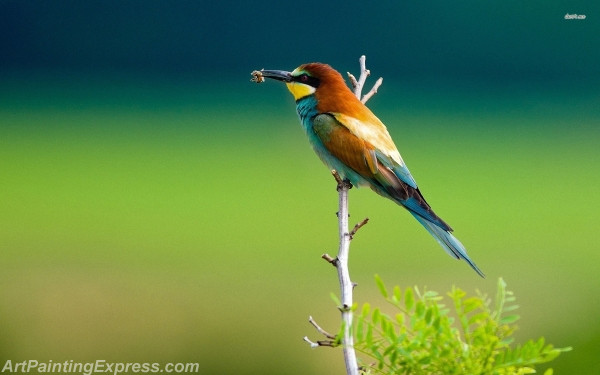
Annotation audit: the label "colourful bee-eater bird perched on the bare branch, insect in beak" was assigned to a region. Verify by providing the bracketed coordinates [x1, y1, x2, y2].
[259, 63, 484, 277]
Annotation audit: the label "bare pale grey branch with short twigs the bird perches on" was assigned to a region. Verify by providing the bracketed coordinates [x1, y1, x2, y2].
[304, 55, 383, 375]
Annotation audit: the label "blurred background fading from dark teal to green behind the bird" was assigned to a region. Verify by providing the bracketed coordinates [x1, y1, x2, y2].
[0, 0, 600, 374]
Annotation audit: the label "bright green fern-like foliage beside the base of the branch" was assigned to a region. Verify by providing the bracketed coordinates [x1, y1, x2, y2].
[354, 276, 571, 375]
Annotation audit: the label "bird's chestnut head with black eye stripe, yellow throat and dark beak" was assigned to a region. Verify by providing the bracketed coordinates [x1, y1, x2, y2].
[260, 63, 352, 101]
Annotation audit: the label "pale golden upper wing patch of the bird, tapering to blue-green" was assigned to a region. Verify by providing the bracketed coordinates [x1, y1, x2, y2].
[331, 113, 417, 189]
